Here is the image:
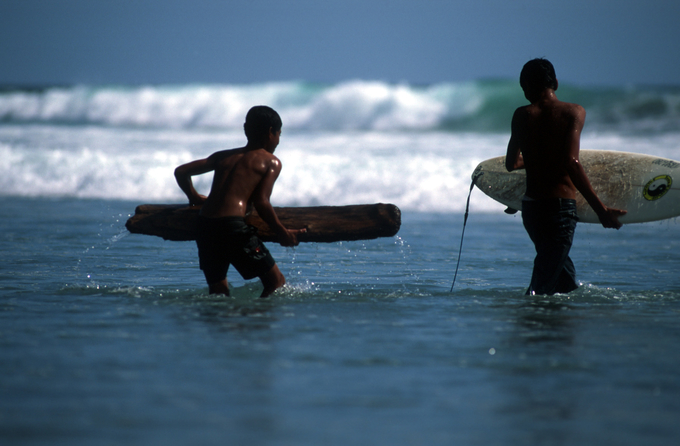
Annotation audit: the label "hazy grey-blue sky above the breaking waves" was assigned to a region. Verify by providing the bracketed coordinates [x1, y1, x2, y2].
[0, 0, 680, 85]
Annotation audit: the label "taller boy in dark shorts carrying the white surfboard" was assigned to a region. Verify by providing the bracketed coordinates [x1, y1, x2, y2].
[505, 59, 626, 294]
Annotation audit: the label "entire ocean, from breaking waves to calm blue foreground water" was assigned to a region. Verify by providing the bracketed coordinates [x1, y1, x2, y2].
[0, 81, 680, 445]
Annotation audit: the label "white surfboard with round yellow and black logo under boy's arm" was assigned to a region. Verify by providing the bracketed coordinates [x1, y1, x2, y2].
[472, 150, 680, 223]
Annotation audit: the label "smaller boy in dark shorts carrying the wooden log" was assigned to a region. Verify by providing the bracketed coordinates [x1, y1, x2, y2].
[175, 105, 305, 297]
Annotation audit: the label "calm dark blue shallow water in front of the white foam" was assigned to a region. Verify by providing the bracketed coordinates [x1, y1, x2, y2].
[0, 198, 680, 445]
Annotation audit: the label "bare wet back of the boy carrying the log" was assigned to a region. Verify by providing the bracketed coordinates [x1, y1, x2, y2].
[201, 148, 280, 217]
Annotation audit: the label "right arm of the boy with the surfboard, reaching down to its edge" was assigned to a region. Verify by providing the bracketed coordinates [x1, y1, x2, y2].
[567, 106, 626, 229]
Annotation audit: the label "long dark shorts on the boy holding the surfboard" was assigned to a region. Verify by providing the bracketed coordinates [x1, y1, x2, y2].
[522, 198, 578, 294]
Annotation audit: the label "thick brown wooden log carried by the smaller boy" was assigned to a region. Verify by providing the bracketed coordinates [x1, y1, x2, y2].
[125, 203, 401, 243]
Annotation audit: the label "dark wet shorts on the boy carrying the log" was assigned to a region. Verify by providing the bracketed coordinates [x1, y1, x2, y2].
[196, 216, 276, 284]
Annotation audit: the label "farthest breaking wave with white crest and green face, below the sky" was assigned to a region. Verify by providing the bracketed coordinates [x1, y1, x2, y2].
[0, 80, 680, 132]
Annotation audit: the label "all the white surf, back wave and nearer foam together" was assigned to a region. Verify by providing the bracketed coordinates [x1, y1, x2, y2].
[0, 80, 680, 212]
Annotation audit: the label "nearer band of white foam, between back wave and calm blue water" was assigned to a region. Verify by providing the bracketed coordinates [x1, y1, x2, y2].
[0, 125, 680, 212]
